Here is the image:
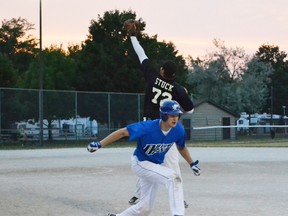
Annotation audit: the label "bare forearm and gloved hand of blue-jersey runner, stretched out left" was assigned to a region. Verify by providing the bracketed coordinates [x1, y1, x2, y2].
[87, 127, 129, 153]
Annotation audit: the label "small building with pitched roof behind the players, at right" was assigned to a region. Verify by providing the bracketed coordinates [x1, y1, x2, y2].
[181, 101, 240, 141]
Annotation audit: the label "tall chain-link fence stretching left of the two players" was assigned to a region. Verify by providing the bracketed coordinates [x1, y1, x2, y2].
[0, 88, 144, 142]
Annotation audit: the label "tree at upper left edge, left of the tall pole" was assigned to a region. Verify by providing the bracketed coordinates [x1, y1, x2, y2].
[0, 17, 37, 87]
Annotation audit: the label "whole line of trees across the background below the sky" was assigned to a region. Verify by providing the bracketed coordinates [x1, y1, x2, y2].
[0, 10, 288, 115]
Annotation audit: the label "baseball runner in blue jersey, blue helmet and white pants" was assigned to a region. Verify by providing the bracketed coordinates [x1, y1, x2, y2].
[87, 100, 200, 216]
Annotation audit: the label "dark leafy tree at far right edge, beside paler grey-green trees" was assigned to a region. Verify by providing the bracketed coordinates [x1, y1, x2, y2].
[256, 44, 288, 115]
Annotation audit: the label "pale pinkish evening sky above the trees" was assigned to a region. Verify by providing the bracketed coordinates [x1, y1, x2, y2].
[0, 0, 288, 57]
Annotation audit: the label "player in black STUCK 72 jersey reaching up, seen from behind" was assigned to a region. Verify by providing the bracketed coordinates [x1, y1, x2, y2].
[129, 30, 194, 208]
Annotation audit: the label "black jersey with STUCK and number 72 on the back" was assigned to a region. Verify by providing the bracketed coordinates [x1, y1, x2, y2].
[141, 59, 194, 119]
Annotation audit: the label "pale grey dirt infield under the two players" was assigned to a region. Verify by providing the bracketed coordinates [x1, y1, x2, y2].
[0, 148, 288, 216]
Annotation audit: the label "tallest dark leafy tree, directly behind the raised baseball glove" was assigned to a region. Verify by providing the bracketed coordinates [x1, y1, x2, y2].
[77, 10, 187, 92]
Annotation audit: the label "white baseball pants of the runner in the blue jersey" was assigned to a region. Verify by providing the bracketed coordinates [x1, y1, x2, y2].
[117, 156, 185, 216]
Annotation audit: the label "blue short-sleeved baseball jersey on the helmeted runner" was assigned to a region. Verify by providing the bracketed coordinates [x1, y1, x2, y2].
[127, 119, 185, 164]
